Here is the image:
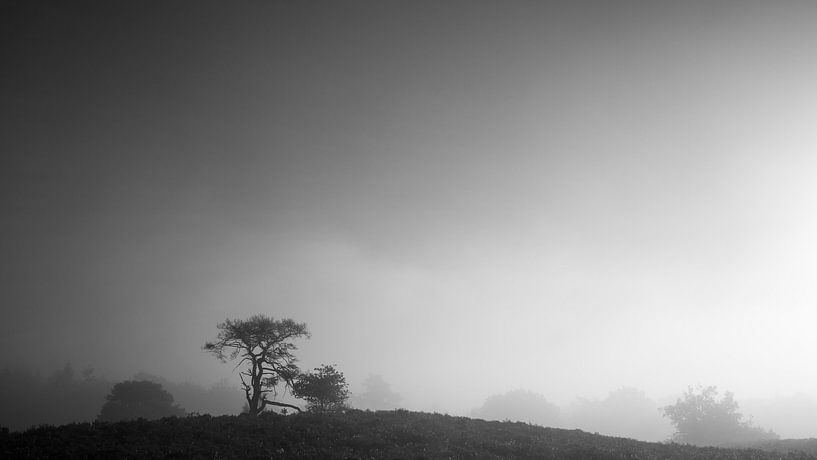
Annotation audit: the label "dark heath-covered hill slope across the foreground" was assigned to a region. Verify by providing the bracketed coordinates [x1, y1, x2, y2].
[0, 410, 817, 459]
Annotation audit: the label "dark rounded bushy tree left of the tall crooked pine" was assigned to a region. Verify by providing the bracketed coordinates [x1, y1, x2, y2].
[97, 380, 184, 422]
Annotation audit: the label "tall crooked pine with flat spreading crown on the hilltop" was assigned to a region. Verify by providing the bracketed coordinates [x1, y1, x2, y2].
[203, 315, 309, 416]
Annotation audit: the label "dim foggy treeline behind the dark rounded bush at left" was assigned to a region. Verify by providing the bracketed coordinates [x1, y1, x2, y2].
[0, 364, 243, 431]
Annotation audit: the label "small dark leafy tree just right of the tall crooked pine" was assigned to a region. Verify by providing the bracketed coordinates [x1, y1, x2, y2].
[293, 364, 349, 413]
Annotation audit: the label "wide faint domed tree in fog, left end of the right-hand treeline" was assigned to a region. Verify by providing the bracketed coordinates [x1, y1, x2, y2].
[472, 390, 559, 426]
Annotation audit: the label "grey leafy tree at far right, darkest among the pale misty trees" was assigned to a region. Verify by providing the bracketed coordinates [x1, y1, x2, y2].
[663, 386, 778, 446]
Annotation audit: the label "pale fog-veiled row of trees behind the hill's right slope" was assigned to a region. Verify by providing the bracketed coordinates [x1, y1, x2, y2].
[470, 386, 817, 446]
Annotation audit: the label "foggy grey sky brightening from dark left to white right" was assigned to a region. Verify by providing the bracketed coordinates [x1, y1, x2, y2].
[0, 0, 817, 413]
